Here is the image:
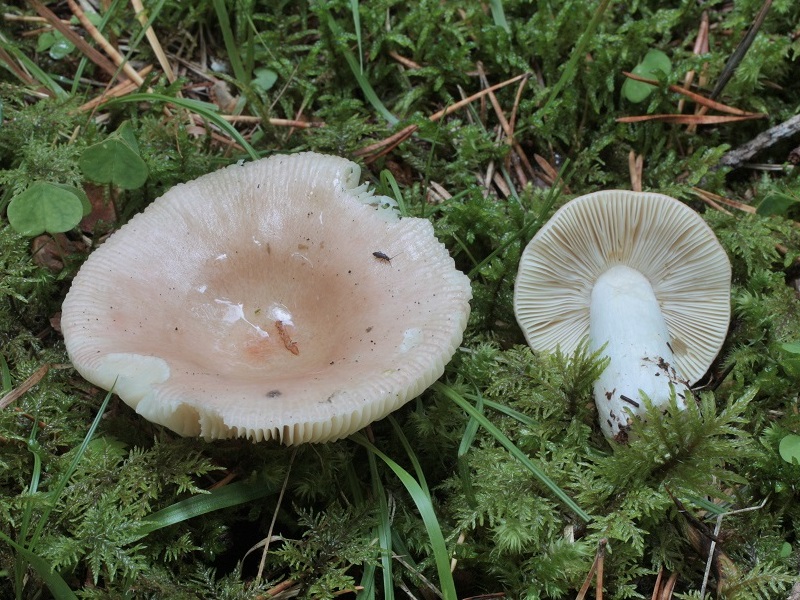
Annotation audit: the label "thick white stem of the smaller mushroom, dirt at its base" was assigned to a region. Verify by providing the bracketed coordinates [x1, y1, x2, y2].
[589, 265, 688, 441]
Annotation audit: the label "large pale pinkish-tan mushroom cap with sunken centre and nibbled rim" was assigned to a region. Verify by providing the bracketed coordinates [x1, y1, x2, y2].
[61, 153, 471, 444]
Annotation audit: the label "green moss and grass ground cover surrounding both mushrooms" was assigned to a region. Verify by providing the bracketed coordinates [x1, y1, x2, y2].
[0, 0, 800, 600]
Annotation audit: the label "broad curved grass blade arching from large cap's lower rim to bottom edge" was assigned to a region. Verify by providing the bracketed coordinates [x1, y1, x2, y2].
[350, 433, 458, 600]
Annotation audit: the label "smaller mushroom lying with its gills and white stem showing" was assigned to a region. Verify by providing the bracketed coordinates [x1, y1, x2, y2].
[514, 190, 731, 441]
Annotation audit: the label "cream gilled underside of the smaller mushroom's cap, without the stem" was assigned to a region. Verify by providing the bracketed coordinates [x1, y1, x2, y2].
[514, 190, 731, 382]
